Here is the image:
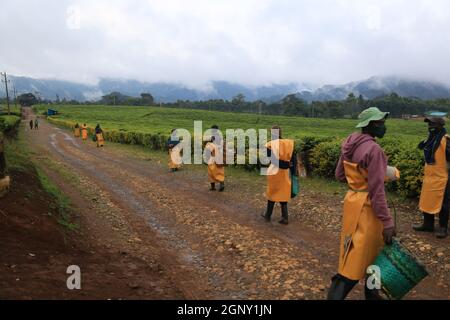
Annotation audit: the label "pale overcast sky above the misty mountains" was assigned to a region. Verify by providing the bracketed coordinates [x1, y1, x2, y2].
[0, 0, 450, 87]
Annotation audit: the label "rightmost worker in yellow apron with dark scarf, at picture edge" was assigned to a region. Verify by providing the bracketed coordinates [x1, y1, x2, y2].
[413, 112, 450, 239]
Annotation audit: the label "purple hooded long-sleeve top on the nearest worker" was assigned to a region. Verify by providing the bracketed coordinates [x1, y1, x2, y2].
[336, 132, 394, 228]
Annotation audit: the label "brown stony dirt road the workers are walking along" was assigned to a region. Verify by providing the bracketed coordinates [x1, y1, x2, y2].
[14, 116, 450, 299]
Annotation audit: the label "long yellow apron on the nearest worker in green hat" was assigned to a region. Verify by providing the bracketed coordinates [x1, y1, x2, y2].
[339, 161, 384, 280]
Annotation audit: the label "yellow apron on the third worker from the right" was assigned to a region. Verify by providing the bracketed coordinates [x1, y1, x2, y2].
[266, 139, 294, 202]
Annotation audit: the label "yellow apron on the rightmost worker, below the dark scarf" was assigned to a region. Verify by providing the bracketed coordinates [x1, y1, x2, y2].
[419, 136, 448, 214]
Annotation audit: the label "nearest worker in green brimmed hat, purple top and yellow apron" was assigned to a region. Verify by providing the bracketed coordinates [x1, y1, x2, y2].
[328, 108, 400, 300]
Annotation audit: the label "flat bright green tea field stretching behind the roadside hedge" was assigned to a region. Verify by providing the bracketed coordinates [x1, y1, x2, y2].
[38, 105, 427, 141]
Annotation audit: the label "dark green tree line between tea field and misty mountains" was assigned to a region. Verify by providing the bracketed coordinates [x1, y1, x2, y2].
[0, 92, 450, 118]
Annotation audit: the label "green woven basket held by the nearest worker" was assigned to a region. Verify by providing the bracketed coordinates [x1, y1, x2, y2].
[374, 239, 428, 300]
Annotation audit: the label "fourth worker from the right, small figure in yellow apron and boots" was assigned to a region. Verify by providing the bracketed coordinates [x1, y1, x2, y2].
[205, 125, 225, 192]
